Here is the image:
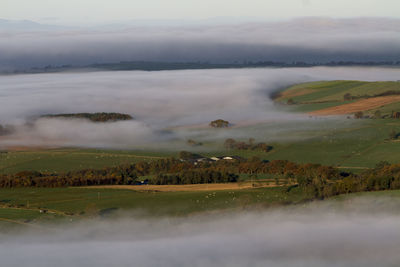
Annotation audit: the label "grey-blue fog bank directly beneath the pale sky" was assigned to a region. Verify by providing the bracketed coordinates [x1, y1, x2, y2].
[0, 18, 400, 70]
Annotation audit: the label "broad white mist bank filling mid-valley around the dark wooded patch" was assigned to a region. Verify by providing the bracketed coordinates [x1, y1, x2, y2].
[0, 67, 399, 149]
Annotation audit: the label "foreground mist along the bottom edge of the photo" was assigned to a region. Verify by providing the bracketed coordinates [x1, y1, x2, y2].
[0, 197, 400, 267]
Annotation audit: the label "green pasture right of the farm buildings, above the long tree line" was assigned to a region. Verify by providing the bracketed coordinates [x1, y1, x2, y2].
[205, 118, 400, 172]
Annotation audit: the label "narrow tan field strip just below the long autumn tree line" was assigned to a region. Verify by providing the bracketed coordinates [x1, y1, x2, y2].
[80, 182, 282, 192]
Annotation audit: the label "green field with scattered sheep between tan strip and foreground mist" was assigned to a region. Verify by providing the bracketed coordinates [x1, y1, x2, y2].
[0, 187, 305, 227]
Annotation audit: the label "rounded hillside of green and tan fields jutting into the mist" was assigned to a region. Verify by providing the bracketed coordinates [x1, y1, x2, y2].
[275, 81, 400, 116]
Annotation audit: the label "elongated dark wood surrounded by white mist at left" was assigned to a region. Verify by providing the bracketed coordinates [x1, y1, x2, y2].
[41, 112, 133, 122]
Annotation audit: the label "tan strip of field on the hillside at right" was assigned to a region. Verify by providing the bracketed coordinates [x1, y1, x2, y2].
[309, 95, 400, 116]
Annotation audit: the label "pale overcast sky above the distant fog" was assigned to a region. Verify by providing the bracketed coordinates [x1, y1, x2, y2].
[0, 0, 400, 25]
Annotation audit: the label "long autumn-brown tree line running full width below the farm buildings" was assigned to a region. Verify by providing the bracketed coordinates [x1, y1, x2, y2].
[0, 158, 400, 204]
